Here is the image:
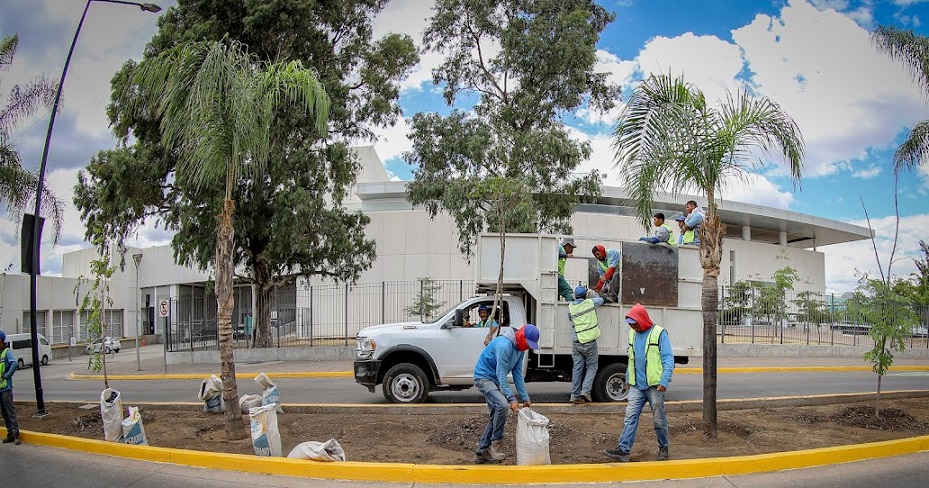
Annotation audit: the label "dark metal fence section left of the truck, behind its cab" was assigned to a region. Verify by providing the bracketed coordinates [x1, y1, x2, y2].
[166, 280, 474, 351]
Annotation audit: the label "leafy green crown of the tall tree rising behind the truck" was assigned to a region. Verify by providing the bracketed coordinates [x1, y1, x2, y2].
[405, 0, 619, 324]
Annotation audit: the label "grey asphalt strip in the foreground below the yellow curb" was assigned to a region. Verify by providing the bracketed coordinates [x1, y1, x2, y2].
[0, 444, 929, 488]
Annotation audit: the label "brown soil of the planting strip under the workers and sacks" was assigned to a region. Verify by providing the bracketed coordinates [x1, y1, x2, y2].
[12, 398, 929, 464]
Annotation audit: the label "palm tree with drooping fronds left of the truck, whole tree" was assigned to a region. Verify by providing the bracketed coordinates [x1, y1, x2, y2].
[127, 41, 329, 439]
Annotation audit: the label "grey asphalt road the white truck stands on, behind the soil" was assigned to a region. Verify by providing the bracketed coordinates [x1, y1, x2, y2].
[14, 350, 929, 405]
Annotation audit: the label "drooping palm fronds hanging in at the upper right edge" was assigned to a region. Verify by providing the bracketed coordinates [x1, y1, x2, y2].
[871, 27, 929, 173]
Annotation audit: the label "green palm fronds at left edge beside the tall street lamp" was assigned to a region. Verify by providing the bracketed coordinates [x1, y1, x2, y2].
[0, 35, 64, 243]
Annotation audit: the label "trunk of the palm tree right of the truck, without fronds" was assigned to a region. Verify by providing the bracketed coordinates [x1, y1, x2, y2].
[700, 214, 726, 437]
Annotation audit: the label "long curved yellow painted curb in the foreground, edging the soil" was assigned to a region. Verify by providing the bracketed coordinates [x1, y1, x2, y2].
[5, 431, 929, 485]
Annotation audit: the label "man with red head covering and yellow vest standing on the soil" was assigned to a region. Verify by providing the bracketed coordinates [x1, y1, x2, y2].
[603, 303, 674, 463]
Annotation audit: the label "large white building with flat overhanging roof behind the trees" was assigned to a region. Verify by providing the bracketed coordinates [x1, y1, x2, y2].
[0, 147, 870, 344]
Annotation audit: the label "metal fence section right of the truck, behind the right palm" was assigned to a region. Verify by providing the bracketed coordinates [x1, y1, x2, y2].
[718, 287, 929, 349]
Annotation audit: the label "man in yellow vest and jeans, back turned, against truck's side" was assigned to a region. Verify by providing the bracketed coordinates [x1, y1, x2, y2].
[568, 286, 603, 403]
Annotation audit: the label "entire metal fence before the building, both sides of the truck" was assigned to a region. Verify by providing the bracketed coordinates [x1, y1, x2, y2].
[166, 280, 929, 351]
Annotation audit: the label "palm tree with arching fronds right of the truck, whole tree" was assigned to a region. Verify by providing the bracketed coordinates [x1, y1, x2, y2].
[614, 75, 803, 437]
